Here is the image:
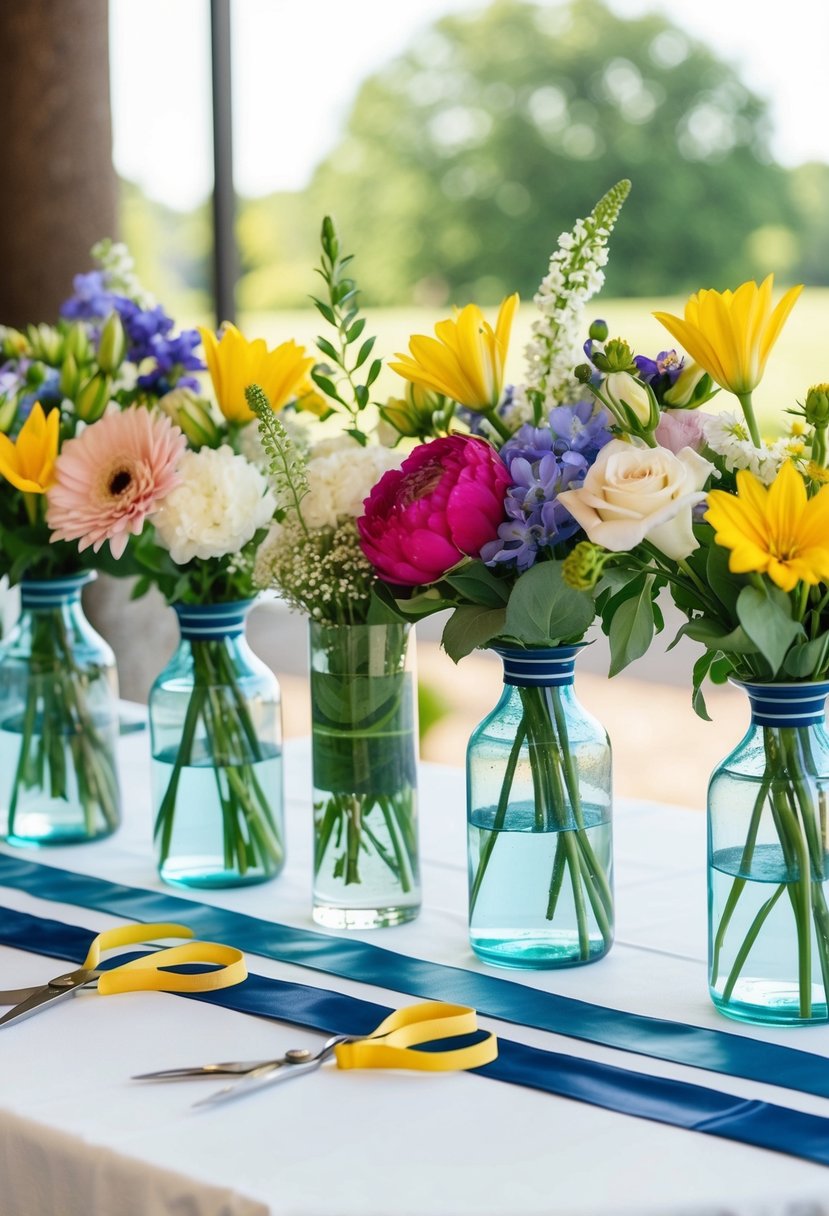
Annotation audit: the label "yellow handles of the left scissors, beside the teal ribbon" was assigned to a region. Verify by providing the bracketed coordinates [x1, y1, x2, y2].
[84, 924, 248, 996]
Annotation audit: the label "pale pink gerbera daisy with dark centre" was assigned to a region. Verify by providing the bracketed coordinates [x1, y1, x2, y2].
[46, 406, 187, 557]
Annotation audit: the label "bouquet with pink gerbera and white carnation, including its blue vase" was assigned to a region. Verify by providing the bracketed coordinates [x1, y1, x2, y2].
[23, 241, 303, 885]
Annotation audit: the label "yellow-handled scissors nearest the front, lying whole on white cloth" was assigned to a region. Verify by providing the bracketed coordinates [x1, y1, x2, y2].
[132, 1001, 498, 1107]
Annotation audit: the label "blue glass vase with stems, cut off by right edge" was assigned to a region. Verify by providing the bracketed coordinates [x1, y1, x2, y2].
[707, 682, 829, 1025]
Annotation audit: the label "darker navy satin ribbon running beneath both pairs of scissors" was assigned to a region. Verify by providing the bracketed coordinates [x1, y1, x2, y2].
[0, 908, 829, 1165]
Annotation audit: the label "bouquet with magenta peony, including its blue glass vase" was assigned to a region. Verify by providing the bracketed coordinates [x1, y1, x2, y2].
[357, 182, 630, 967]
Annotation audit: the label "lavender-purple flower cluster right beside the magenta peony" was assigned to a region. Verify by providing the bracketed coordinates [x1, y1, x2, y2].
[480, 401, 613, 574]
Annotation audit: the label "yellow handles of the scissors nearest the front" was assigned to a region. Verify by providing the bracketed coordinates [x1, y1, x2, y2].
[334, 1001, 498, 1073]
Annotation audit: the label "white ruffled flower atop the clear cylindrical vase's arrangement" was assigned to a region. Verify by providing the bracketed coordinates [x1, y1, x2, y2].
[301, 437, 404, 528]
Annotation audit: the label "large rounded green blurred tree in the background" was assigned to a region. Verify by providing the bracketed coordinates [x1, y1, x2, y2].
[309, 0, 795, 304]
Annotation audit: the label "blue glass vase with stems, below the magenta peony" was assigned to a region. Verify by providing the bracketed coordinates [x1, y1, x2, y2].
[467, 646, 614, 968]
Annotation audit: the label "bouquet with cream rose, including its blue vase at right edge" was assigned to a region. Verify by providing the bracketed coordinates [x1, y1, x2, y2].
[565, 276, 829, 1024]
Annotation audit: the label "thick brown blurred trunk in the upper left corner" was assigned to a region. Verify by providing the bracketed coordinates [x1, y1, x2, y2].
[0, 0, 115, 325]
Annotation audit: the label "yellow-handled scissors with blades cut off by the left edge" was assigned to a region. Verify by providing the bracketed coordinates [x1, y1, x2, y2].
[0, 924, 248, 1026]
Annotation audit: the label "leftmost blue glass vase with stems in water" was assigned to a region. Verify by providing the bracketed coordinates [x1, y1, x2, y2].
[0, 573, 120, 845]
